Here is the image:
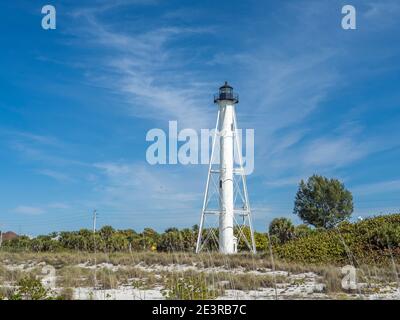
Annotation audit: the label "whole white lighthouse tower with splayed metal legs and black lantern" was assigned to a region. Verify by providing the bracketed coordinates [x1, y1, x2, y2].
[196, 82, 256, 254]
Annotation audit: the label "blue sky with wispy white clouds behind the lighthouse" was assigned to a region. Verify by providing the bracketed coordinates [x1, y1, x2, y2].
[0, 0, 400, 234]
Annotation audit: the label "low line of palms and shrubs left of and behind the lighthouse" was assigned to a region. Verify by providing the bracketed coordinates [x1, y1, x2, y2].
[3, 226, 268, 253]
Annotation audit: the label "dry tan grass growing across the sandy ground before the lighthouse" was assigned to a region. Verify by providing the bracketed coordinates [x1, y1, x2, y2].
[0, 252, 398, 299]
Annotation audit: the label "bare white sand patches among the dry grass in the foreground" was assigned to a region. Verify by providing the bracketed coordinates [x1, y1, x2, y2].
[3, 262, 400, 300]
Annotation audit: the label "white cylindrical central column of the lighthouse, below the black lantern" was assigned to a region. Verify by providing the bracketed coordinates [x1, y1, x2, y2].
[219, 101, 235, 254]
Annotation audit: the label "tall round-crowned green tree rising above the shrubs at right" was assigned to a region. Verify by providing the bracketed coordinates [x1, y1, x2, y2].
[293, 175, 353, 229]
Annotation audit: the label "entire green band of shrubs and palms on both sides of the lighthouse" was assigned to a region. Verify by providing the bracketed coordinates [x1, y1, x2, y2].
[2, 214, 400, 265]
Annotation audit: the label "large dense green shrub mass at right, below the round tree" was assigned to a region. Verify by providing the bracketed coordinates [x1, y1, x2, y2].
[274, 214, 400, 264]
